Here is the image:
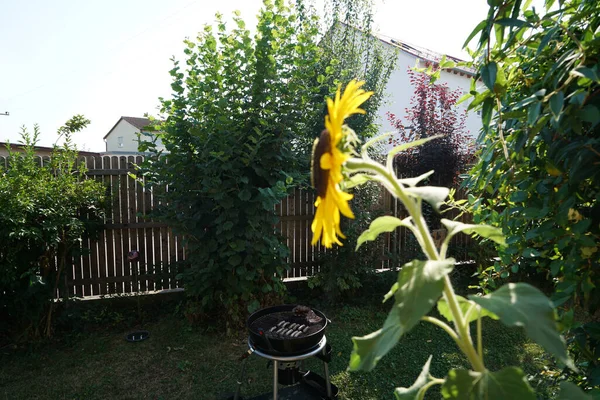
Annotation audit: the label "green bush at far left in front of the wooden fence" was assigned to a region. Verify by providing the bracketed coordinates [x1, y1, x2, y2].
[0, 116, 105, 336]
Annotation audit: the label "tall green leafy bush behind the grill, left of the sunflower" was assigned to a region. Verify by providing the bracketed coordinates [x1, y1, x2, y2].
[143, 0, 344, 323]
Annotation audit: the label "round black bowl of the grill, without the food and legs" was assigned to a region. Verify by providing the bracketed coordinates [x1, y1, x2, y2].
[247, 304, 327, 356]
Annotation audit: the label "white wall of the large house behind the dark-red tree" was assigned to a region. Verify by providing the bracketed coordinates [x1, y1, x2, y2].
[377, 50, 482, 150]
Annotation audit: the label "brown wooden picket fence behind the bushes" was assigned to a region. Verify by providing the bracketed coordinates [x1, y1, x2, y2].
[0, 156, 468, 297]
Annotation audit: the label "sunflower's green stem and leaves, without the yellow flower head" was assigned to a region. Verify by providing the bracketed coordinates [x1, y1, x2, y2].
[334, 101, 579, 400]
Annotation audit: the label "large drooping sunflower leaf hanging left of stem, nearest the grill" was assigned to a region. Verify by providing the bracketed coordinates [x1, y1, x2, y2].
[348, 258, 455, 371]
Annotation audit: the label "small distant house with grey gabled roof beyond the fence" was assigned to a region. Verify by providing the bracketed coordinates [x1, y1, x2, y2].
[104, 117, 164, 155]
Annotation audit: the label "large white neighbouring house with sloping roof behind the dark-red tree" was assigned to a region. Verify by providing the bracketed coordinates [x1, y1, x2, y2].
[376, 35, 482, 149]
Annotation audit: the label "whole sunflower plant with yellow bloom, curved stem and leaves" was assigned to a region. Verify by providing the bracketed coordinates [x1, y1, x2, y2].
[312, 81, 585, 400]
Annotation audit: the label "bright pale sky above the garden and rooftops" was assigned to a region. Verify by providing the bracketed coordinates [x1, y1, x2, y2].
[0, 0, 487, 151]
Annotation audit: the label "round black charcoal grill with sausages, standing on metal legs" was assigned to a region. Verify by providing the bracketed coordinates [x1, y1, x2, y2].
[232, 304, 338, 400]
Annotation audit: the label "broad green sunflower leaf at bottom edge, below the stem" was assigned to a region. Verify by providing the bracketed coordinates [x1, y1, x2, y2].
[442, 367, 536, 400]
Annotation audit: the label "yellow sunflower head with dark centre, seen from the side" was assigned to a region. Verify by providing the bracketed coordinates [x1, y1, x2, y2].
[311, 80, 373, 248]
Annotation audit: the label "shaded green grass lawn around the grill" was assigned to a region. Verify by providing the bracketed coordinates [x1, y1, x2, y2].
[0, 298, 543, 400]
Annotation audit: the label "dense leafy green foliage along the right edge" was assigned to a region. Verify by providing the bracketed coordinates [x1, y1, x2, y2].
[467, 0, 600, 311]
